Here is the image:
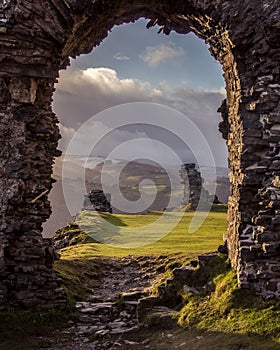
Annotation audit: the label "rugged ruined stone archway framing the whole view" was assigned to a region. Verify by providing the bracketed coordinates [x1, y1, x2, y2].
[0, 0, 280, 306]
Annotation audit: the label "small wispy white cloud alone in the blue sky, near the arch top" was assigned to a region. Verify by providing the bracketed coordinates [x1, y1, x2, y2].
[140, 41, 184, 67]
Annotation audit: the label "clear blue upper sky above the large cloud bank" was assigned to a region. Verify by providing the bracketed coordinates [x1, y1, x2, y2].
[73, 19, 225, 90]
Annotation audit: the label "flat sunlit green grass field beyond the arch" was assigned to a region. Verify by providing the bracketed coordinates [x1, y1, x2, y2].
[62, 212, 227, 260]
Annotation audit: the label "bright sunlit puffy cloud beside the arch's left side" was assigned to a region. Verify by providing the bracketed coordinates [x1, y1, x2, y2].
[53, 67, 162, 129]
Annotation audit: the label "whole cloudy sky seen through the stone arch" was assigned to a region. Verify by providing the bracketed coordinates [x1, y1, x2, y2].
[53, 19, 227, 167]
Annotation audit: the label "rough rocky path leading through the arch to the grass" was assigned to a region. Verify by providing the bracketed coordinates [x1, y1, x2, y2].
[42, 256, 174, 350]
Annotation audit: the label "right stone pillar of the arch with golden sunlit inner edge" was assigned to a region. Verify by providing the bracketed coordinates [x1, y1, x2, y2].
[221, 59, 280, 298]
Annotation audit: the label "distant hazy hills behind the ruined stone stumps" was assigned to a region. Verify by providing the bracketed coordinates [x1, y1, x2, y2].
[43, 156, 229, 236]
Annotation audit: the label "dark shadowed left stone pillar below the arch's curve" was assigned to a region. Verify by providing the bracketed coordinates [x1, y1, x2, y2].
[0, 72, 64, 307]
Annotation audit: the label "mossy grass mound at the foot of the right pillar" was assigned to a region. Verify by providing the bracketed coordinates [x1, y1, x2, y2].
[178, 260, 280, 342]
